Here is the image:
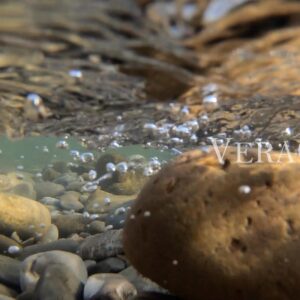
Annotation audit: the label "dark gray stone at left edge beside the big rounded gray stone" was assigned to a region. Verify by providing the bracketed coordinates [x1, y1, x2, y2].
[0, 255, 21, 288]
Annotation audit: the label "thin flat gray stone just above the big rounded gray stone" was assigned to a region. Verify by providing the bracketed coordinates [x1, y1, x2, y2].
[19, 239, 80, 259]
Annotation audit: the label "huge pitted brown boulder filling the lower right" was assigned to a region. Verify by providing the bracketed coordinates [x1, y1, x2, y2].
[124, 148, 300, 300]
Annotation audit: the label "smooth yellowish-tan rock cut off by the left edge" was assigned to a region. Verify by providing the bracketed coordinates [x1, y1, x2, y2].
[0, 193, 51, 239]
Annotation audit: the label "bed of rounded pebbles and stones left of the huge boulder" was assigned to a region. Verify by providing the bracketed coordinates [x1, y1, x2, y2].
[0, 146, 171, 300]
